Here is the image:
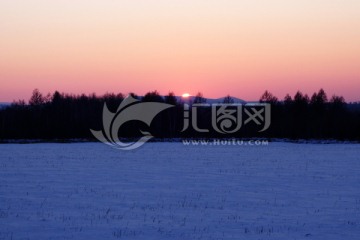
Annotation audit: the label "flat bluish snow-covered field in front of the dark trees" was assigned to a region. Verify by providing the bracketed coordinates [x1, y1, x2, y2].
[0, 143, 360, 240]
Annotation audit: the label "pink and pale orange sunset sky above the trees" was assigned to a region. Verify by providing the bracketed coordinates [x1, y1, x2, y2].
[0, 0, 360, 102]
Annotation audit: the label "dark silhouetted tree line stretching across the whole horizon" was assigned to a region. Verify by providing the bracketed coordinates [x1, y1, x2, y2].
[0, 89, 360, 140]
